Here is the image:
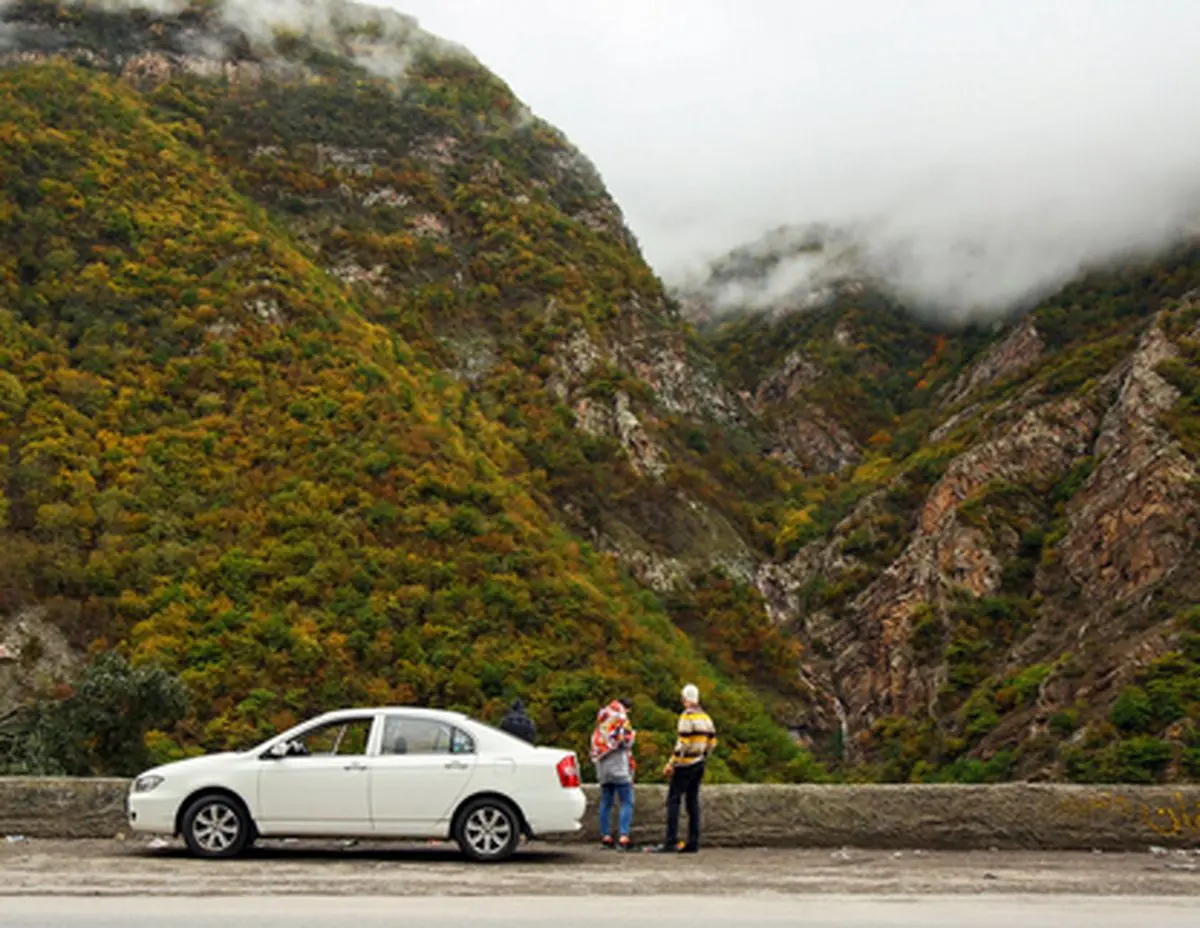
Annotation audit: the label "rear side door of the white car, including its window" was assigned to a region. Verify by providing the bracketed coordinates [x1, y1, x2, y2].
[370, 713, 476, 838]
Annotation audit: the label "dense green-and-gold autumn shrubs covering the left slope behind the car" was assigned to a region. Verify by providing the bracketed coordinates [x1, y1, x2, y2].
[0, 28, 809, 778]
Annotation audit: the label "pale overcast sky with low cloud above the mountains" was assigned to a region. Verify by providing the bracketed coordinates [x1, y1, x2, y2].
[389, 0, 1200, 312]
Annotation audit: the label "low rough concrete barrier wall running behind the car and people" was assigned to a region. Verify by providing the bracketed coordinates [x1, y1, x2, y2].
[0, 778, 1200, 850]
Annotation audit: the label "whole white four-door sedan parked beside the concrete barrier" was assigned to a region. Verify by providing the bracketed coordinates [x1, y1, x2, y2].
[128, 708, 587, 861]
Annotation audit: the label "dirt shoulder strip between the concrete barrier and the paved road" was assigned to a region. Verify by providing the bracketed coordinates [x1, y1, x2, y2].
[0, 838, 1200, 896]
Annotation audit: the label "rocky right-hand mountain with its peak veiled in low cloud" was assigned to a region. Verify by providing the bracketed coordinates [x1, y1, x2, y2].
[686, 228, 1200, 782]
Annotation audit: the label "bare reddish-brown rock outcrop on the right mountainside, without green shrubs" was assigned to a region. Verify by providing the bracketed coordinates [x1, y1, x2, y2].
[756, 303, 1200, 760]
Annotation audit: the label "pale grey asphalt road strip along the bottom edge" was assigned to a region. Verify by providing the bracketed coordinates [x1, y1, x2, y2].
[0, 896, 1200, 928]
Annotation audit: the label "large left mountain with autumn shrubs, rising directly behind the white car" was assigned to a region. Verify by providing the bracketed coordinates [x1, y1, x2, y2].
[0, 0, 821, 778]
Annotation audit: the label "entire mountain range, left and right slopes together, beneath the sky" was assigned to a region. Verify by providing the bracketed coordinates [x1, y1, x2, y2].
[0, 0, 1200, 782]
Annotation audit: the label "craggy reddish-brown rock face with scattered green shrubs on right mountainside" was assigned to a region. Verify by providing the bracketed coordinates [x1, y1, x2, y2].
[756, 284, 1200, 776]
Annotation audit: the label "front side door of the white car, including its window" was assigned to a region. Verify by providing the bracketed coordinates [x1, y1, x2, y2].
[258, 713, 376, 837]
